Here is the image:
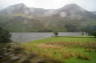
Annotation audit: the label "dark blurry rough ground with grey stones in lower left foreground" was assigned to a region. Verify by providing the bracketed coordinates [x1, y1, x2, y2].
[0, 42, 61, 63]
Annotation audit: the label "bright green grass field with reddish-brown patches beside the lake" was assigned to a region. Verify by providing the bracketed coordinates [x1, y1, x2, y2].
[22, 37, 96, 63]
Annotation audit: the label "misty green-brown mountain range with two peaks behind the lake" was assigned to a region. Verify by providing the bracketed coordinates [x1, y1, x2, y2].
[0, 3, 96, 32]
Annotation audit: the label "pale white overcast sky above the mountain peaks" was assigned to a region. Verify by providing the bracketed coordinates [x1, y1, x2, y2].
[0, 0, 96, 11]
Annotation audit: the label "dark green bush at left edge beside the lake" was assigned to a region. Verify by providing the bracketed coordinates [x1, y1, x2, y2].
[0, 27, 11, 42]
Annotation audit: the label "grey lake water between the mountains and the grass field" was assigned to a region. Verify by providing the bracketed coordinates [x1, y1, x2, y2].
[11, 32, 82, 42]
